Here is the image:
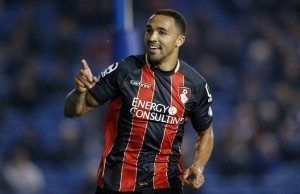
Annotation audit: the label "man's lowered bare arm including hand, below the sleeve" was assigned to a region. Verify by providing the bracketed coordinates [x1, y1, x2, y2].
[184, 126, 214, 188]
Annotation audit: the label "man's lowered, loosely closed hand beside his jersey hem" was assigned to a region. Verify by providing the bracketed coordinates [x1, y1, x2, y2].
[183, 165, 204, 189]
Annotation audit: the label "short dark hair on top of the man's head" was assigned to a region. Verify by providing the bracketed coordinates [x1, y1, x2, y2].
[154, 9, 186, 36]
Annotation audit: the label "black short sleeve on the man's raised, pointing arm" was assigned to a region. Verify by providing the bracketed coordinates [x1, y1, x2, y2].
[89, 61, 126, 104]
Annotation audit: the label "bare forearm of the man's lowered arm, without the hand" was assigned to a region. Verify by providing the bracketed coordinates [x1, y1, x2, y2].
[193, 126, 214, 171]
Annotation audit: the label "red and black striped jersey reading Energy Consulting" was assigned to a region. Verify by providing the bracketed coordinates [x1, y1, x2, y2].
[90, 55, 212, 191]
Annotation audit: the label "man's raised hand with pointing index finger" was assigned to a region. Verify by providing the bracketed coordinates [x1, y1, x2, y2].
[74, 60, 99, 93]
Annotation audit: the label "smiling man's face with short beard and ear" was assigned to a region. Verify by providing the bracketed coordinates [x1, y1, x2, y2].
[145, 15, 184, 64]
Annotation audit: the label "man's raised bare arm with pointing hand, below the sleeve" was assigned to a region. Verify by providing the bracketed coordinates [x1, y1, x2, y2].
[64, 60, 99, 118]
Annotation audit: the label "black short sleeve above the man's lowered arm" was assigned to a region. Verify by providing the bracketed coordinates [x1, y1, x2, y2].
[190, 82, 213, 132]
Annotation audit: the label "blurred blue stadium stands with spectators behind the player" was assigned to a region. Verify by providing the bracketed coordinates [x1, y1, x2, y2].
[0, 0, 300, 194]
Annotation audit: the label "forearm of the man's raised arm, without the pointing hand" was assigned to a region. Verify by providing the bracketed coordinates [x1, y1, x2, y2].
[64, 89, 88, 118]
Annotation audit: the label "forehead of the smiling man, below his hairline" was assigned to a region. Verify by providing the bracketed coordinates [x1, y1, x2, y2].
[147, 15, 177, 30]
